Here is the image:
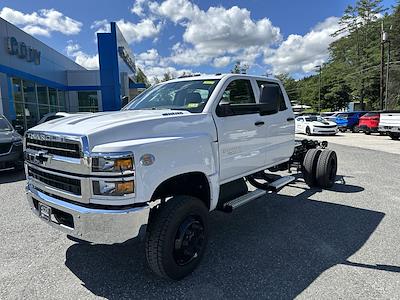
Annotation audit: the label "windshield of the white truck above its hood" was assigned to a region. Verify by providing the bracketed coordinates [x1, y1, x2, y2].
[123, 80, 219, 113]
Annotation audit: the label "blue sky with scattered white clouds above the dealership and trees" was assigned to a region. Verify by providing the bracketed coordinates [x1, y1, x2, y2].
[0, 0, 395, 78]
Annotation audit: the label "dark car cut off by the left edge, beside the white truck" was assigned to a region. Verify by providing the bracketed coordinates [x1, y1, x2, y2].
[0, 115, 24, 171]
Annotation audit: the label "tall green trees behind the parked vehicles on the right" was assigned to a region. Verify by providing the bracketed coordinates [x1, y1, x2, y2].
[278, 0, 400, 111]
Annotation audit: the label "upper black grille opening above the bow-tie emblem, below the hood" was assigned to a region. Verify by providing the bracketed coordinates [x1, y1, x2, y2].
[26, 136, 82, 158]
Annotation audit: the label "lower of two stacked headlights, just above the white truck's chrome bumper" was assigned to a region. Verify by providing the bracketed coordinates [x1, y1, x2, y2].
[93, 180, 135, 196]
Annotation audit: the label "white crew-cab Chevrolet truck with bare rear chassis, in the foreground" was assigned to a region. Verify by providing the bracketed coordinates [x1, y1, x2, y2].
[25, 74, 337, 280]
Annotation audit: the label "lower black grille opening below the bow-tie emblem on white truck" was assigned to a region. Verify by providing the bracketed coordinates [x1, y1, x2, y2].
[28, 166, 82, 196]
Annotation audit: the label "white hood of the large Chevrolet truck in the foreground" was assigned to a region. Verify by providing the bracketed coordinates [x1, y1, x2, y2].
[29, 109, 216, 148]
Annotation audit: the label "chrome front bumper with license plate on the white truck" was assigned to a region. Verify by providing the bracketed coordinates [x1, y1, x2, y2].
[26, 185, 150, 244]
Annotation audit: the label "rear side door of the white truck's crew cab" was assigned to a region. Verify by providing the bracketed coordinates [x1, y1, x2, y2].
[256, 80, 295, 166]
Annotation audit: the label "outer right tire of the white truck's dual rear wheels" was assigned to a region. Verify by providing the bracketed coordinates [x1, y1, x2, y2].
[316, 150, 337, 188]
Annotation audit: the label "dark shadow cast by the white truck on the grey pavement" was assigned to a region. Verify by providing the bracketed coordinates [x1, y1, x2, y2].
[65, 184, 386, 299]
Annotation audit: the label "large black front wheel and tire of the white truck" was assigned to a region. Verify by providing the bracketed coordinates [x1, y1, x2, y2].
[146, 196, 208, 280]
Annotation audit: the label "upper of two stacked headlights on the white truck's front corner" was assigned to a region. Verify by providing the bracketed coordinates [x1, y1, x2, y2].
[92, 152, 135, 173]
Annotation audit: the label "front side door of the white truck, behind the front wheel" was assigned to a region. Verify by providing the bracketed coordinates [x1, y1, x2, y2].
[214, 78, 267, 182]
